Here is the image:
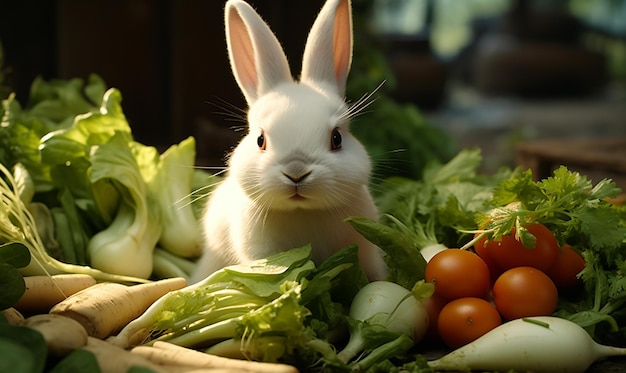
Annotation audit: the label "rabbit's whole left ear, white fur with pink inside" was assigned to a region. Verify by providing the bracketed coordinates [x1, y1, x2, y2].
[225, 0, 293, 105]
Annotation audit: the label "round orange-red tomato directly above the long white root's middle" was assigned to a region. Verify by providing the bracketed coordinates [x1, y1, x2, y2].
[493, 267, 559, 320]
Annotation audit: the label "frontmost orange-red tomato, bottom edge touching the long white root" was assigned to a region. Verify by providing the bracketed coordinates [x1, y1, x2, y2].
[437, 297, 502, 348]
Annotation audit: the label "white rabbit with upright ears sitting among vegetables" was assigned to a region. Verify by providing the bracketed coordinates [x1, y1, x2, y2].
[191, 0, 386, 282]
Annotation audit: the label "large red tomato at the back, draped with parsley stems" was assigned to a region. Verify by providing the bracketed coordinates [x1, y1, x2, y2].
[476, 224, 559, 272]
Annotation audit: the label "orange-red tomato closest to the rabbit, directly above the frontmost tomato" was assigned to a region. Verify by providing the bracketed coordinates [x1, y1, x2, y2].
[424, 249, 491, 299]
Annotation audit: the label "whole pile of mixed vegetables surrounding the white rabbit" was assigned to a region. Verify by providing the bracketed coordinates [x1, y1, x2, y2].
[0, 70, 626, 372]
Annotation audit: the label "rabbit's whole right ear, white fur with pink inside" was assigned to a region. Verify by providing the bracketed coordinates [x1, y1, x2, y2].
[301, 0, 352, 97]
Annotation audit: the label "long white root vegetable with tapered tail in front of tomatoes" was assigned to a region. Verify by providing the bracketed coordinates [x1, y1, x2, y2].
[428, 316, 626, 373]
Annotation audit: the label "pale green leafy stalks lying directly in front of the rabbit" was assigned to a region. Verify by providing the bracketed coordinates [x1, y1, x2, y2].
[111, 246, 326, 346]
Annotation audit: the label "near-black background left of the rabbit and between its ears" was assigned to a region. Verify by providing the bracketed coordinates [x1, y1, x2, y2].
[0, 0, 330, 164]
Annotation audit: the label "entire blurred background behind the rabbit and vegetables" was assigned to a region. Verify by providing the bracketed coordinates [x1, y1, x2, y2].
[0, 0, 626, 188]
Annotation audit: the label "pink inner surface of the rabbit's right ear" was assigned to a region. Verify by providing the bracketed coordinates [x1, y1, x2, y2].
[333, 1, 352, 92]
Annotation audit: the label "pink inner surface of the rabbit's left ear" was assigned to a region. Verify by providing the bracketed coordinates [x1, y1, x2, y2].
[226, 11, 259, 100]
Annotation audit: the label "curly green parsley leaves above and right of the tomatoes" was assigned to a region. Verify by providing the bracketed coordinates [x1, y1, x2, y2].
[476, 166, 626, 344]
